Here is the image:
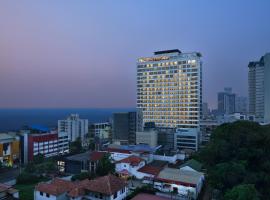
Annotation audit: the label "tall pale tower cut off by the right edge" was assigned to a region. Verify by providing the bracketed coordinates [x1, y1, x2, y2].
[248, 53, 270, 123]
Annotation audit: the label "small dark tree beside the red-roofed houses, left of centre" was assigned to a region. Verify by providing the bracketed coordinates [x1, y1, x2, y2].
[96, 154, 115, 176]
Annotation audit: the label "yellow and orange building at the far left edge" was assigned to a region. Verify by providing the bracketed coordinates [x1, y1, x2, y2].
[0, 133, 20, 167]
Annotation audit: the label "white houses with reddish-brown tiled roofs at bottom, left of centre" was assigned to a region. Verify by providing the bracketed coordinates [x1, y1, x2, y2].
[34, 175, 128, 200]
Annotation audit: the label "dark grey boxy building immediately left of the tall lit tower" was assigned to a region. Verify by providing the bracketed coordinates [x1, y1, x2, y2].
[112, 112, 137, 144]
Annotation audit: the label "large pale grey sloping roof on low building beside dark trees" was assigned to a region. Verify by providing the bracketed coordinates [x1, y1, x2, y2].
[156, 167, 204, 186]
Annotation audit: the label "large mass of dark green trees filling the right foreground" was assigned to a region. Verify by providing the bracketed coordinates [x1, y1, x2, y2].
[196, 121, 270, 199]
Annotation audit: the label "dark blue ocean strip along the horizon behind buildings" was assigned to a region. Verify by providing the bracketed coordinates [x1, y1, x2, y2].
[0, 108, 135, 132]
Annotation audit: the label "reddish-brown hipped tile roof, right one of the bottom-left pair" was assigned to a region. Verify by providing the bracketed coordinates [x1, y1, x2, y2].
[85, 174, 127, 195]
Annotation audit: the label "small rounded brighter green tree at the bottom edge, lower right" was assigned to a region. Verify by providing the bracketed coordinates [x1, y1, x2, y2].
[224, 184, 259, 200]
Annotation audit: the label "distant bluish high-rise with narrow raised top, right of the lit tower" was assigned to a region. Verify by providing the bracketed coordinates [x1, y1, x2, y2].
[218, 88, 235, 115]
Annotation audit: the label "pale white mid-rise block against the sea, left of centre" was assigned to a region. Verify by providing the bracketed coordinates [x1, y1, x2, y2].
[58, 114, 88, 143]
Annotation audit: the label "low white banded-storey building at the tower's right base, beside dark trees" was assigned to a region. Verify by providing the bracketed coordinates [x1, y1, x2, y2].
[175, 128, 200, 151]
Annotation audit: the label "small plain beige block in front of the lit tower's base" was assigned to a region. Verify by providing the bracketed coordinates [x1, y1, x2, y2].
[136, 130, 158, 147]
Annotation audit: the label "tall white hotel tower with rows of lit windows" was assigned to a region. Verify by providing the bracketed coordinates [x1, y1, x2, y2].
[137, 49, 202, 128]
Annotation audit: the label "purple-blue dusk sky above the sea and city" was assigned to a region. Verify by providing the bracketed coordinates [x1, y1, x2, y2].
[0, 0, 270, 108]
